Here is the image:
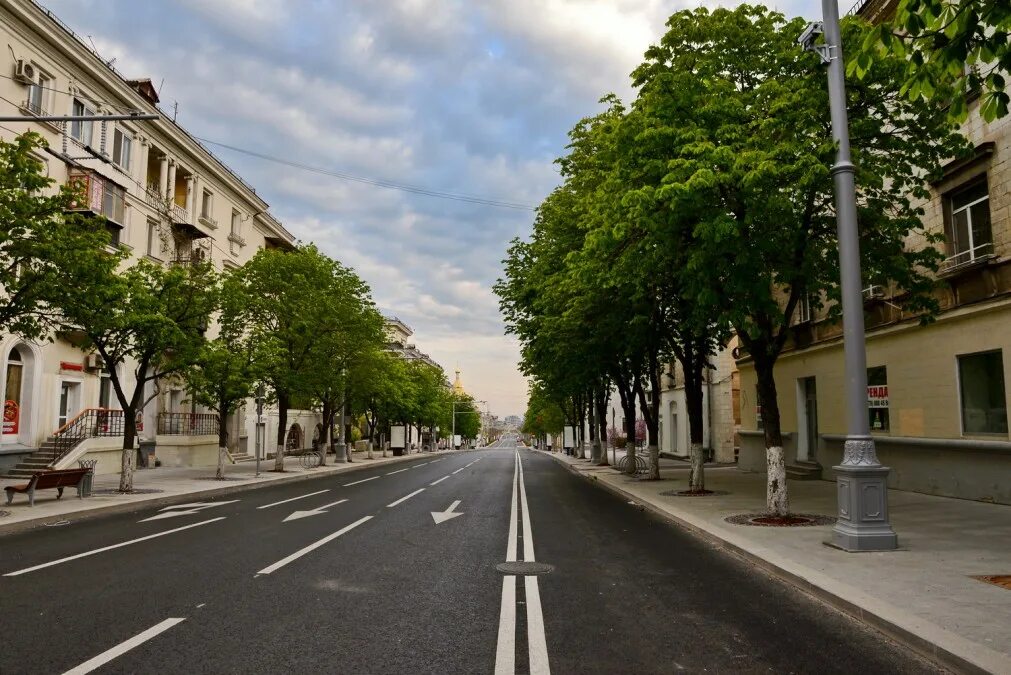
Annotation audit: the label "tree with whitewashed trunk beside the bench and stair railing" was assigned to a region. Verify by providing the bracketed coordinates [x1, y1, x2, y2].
[55, 258, 216, 492]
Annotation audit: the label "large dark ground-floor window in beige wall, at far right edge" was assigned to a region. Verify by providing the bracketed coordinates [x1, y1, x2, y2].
[958, 350, 1008, 435]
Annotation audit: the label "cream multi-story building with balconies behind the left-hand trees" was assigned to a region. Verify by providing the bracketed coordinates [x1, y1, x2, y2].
[0, 0, 293, 471]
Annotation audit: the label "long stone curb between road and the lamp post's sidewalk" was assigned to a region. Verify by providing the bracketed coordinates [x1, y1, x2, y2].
[550, 454, 1000, 675]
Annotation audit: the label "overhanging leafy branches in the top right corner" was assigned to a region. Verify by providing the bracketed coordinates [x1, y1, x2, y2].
[847, 0, 1011, 122]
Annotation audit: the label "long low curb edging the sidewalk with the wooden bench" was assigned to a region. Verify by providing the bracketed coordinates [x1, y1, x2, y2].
[0, 451, 463, 537]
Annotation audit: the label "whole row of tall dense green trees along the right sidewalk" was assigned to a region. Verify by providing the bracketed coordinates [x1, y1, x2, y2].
[496, 3, 969, 514]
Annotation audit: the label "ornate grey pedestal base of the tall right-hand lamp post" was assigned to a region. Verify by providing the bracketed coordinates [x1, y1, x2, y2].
[827, 464, 899, 552]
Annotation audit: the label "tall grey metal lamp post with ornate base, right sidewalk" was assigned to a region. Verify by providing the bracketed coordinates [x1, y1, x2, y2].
[800, 0, 898, 551]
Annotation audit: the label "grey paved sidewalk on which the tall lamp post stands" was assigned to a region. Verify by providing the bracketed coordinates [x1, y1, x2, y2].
[551, 453, 1011, 673]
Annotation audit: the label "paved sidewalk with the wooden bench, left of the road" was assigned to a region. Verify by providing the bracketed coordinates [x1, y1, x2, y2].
[0, 451, 449, 535]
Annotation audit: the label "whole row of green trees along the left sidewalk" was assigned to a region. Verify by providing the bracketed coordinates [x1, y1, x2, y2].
[0, 133, 476, 491]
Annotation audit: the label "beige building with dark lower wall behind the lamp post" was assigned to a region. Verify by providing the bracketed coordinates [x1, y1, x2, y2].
[739, 0, 1011, 503]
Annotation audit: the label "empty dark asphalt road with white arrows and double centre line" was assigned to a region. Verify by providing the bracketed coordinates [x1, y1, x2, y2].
[0, 440, 933, 675]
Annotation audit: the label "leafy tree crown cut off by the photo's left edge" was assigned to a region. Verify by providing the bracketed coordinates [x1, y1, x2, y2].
[0, 132, 112, 340]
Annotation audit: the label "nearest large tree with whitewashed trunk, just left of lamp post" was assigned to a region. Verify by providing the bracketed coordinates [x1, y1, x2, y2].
[633, 5, 966, 514]
